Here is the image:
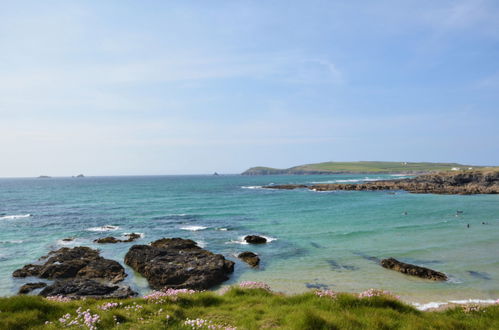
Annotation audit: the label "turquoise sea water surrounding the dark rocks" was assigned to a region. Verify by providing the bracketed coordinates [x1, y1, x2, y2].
[0, 175, 499, 303]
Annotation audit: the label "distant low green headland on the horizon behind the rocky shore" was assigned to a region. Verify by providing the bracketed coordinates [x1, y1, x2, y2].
[242, 161, 482, 175]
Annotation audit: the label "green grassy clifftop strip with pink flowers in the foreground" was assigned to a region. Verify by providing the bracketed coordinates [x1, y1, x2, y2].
[0, 288, 499, 330]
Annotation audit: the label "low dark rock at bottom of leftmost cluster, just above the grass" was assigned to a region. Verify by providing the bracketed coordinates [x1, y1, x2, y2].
[40, 279, 137, 299]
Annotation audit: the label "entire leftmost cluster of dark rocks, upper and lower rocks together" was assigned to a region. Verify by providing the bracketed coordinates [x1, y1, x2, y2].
[12, 246, 134, 298]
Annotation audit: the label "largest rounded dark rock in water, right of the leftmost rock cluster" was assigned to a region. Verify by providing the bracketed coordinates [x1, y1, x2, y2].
[125, 238, 234, 290]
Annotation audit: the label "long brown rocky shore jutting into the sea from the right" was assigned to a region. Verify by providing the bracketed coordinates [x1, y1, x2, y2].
[263, 170, 499, 195]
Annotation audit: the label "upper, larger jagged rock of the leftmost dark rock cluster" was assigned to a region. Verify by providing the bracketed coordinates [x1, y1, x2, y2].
[12, 246, 126, 283]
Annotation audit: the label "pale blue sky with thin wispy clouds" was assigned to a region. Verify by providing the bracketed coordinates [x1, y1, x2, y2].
[0, 0, 499, 177]
